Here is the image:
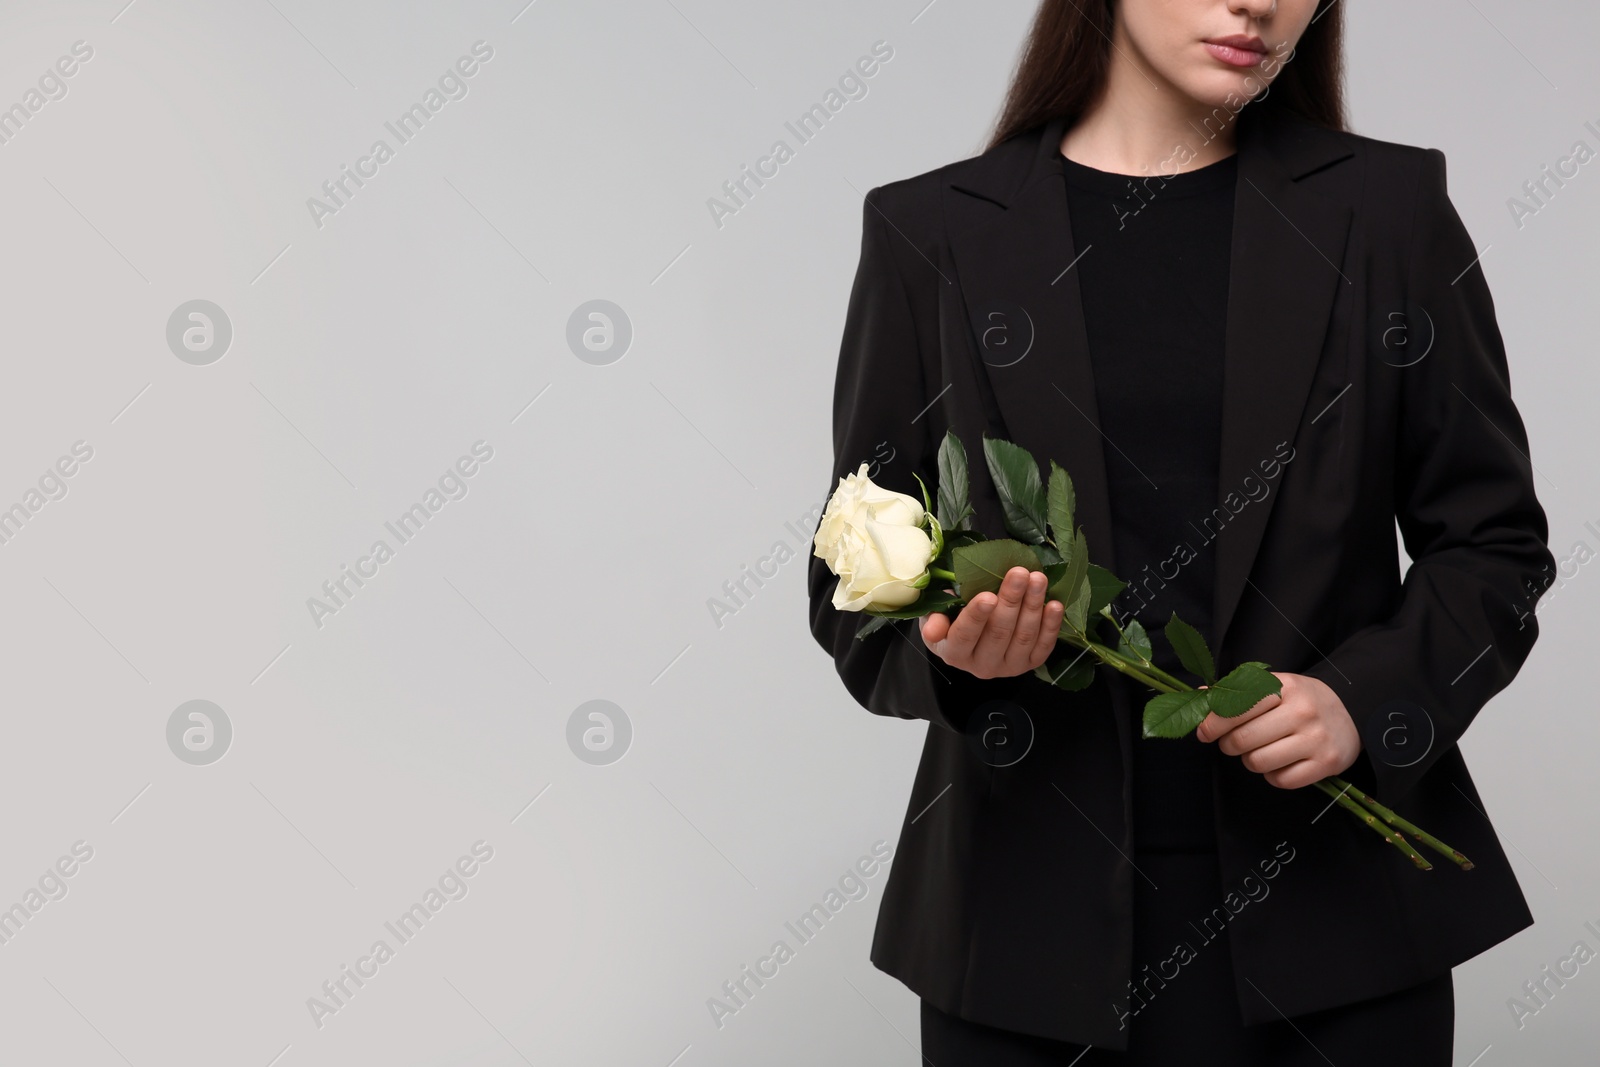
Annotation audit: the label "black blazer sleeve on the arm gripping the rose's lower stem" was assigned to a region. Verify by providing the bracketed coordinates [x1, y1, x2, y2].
[1306, 149, 1554, 803]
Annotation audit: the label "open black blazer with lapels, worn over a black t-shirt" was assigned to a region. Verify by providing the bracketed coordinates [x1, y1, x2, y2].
[808, 104, 1554, 1049]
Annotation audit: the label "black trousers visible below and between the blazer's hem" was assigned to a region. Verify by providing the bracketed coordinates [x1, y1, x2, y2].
[922, 851, 1456, 1067]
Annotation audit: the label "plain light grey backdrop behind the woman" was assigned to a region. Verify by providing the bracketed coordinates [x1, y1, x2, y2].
[0, 0, 1600, 1067]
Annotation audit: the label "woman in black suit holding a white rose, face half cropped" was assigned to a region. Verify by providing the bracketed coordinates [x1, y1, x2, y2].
[808, 0, 1554, 1067]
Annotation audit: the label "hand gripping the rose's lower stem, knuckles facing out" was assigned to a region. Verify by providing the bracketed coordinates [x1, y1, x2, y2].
[1195, 670, 1362, 789]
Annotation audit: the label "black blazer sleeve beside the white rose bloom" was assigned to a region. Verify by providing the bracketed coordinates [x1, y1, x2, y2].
[808, 187, 1043, 731]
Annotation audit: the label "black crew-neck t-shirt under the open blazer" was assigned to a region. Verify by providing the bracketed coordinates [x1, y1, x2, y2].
[1061, 155, 1237, 851]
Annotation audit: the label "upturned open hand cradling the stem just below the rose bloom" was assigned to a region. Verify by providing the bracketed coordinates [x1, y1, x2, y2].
[920, 566, 1066, 678]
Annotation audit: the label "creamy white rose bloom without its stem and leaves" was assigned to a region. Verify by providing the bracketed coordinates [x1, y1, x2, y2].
[811, 462, 933, 611]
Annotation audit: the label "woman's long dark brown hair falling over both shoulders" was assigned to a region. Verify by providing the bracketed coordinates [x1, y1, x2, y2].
[986, 0, 1346, 149]
